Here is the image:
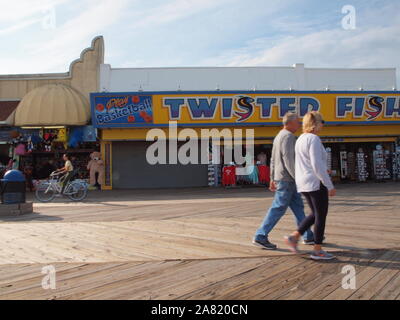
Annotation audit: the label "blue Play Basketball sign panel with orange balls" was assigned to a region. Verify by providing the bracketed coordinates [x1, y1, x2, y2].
[90, 93, 153, 128]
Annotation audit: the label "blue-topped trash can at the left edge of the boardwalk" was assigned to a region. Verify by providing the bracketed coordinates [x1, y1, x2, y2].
[0, 170, 26, 204]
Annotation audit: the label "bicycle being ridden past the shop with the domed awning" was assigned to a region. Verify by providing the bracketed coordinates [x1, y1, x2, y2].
[35, 172, 88, 202]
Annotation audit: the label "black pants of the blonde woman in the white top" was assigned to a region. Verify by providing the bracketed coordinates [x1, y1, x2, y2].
[297, 183, 329, 244]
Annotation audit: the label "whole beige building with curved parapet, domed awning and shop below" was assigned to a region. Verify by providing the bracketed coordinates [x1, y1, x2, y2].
[0, 36, 104, 179]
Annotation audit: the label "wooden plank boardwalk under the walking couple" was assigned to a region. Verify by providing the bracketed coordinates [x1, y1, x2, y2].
[0, 183, 400, 300]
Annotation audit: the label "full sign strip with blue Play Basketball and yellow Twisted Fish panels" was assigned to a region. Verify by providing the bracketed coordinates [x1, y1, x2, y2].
[91, 91, 400, 128]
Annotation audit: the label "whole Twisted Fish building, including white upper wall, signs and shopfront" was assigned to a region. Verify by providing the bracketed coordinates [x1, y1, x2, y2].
[91, 64, 400, 189]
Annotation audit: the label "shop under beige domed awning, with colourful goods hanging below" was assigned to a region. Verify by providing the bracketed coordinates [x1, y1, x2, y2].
[9, 84, 100, 185]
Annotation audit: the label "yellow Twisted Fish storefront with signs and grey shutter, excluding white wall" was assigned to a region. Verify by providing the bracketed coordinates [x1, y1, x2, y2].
[91, 91, 400, 189]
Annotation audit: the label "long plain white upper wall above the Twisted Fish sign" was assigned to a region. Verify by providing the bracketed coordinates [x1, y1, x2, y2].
[100, 64, 396, 92]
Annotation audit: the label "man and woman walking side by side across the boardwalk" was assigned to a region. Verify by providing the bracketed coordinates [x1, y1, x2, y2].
[253, 111, 336, 260]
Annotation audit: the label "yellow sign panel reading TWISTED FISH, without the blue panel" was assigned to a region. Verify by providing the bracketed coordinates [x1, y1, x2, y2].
[153, 92, 400, 125]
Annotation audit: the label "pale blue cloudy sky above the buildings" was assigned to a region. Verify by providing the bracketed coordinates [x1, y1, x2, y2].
[0, 0, 400, 86]
